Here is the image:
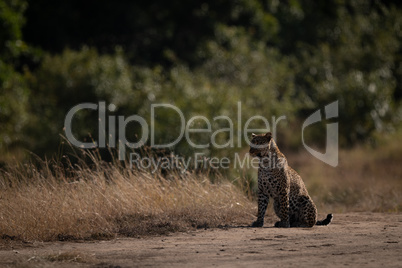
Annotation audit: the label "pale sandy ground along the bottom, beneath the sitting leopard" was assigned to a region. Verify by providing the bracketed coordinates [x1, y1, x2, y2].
[0, 213, 402, 268]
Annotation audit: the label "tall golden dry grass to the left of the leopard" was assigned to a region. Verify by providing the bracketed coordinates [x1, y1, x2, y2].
[0, 155, 255, 241]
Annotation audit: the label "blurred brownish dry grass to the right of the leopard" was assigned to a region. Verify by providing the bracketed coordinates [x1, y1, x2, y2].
[287, 135, 402, 213]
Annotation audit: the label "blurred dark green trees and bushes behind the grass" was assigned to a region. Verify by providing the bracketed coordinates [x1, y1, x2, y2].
[0, 0, 402, 164]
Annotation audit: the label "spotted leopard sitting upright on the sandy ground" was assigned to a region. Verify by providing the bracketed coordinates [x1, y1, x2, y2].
[249, 132, 333, 228]
